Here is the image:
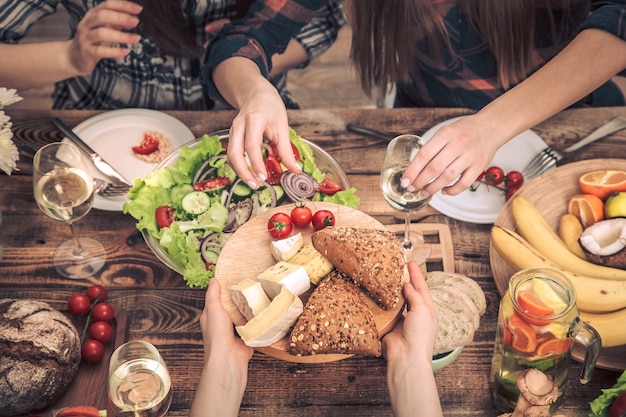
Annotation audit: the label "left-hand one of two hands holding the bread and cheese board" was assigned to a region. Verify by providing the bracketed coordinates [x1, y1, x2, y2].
[200, 278, 253, 366]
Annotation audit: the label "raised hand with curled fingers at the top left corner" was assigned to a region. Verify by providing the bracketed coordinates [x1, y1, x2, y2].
[69, 0, 142, 74]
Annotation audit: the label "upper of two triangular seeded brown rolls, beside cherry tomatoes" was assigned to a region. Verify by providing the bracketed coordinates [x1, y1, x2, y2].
[311, 227, 406, 310]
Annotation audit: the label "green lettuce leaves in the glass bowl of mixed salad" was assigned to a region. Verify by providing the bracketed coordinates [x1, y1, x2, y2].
[122, 129, 360, 288]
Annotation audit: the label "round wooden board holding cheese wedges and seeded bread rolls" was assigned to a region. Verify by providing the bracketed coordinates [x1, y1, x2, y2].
[215, 202, 404, 363]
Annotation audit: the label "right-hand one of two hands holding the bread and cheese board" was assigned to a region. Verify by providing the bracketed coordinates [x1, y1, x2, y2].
[382, 261, 438, 362]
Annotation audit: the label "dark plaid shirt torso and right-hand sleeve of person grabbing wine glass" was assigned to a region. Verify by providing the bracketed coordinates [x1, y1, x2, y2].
[396, 0, 626, 109]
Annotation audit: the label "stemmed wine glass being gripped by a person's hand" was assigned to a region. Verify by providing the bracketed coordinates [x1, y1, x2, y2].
[380, 135, 431, 265]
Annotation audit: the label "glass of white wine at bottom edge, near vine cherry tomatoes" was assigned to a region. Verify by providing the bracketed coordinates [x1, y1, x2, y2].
[109, 341, 172, 417]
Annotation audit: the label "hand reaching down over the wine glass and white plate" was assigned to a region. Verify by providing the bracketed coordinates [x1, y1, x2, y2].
[402, 115, 503, 195]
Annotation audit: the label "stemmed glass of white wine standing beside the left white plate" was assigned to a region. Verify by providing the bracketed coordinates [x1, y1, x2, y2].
[33, 142, 106, 279]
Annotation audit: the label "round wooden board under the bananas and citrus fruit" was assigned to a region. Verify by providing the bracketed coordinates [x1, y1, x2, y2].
[489, 159, 626, 371]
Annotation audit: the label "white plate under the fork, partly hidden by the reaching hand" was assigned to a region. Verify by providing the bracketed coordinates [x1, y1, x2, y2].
[422, 116, 547, 224]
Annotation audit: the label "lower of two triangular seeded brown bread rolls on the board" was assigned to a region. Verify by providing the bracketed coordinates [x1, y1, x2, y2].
[289, 270, 382, 356]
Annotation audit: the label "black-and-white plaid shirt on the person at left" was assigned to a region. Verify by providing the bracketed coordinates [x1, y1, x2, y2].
[0, 0, 346, 110]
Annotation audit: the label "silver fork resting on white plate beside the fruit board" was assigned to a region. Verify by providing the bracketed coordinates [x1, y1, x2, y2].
[522, 116, 626, 179]
